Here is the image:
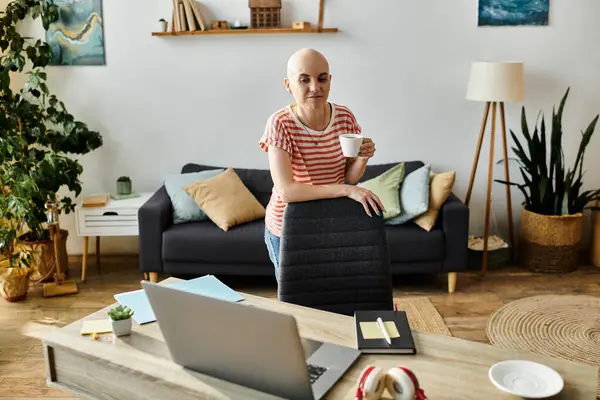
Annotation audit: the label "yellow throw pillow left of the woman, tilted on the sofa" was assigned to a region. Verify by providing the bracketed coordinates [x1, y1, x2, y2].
[183, 168, 265, 231]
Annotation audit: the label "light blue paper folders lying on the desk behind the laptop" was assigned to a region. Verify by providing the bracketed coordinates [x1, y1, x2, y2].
[114, 275, 244, 325]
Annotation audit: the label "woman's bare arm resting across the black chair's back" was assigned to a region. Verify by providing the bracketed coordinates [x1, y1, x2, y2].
[268, 145, 385, 216]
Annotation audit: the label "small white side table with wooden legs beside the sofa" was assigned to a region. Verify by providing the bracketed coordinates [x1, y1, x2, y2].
[75, 192, 154, 282]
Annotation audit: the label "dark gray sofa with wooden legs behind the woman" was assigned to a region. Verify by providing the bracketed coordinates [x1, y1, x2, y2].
[138, 161, 469, 292]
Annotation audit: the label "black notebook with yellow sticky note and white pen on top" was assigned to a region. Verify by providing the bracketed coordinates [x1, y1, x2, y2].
[354, 310, 417, 354]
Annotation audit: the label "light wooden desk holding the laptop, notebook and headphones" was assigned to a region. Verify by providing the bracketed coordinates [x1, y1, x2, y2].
[43, 278, 598, 400]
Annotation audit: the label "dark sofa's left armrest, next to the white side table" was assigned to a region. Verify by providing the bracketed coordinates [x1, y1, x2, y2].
[138, 185, 173, 272]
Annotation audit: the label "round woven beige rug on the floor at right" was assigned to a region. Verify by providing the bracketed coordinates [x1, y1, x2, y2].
[486, 295, 600, 394]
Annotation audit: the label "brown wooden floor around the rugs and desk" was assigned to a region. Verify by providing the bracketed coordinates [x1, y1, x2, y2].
[0, 256, 600, 399]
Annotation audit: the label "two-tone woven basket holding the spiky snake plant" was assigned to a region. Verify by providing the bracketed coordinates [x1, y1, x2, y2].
[518, 209, 583, 273]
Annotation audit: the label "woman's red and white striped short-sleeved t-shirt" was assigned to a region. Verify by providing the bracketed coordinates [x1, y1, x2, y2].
[259, 103, 361, 236]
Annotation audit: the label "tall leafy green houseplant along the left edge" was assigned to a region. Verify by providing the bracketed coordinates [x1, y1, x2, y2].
[0, 0, 102, 300]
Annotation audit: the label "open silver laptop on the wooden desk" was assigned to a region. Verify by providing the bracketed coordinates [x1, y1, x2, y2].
[142, 281, 360, 399]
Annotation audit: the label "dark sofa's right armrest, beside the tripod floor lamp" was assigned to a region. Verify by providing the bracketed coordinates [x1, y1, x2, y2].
[440, 193, 469, 272]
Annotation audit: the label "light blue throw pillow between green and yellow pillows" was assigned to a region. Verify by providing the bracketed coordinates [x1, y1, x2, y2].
[385, 164, 431, 225]
